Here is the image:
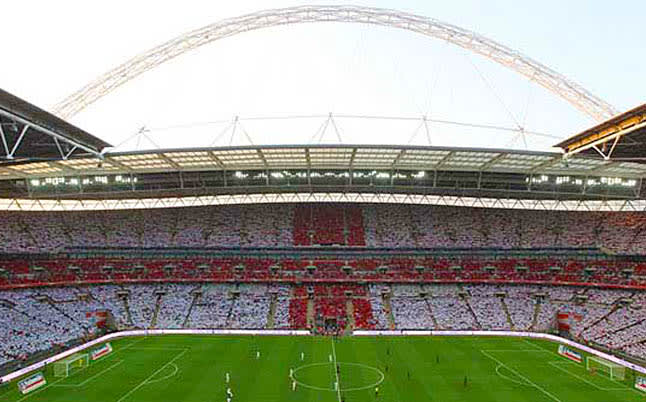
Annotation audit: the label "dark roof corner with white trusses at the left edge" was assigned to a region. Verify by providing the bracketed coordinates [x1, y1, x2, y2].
[0, 89, 110, 163]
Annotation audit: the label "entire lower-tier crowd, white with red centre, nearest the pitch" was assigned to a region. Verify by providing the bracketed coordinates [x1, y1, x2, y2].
[0, 283, 646, 361]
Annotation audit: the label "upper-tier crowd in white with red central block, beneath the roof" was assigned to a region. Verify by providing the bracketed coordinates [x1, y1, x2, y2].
[0, 204, 646, 254]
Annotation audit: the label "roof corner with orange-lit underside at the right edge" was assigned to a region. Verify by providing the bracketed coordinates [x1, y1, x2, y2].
[556, 104, 646, 163]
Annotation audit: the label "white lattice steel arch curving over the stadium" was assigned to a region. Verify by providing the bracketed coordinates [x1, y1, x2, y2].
[54, 5, 617, 121]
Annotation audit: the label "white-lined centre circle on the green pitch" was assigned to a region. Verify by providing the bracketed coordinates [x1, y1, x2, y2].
[291, 362, 385, 392]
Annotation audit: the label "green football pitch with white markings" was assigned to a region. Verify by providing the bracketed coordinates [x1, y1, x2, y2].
[0, 335, 645, 402]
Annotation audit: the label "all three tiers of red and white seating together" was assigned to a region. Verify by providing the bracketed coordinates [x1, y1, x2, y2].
[0, 204, 646, 361]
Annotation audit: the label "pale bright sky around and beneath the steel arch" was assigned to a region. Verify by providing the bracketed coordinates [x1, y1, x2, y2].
[0, 0, 646, 149]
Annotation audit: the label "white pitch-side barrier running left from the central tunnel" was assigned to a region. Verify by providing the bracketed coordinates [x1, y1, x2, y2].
[0, 329, 311, 383]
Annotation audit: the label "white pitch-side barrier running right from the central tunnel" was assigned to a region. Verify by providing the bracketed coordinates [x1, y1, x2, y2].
[352, 330, 646, 374]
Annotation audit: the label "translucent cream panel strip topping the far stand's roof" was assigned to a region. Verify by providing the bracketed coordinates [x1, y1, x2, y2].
[0, 145, 646, 179]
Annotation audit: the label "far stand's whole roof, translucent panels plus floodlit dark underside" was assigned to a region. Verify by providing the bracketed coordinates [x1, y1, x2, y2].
[0, 145, 646, 204]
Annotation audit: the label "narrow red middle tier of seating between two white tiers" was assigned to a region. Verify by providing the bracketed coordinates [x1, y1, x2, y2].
[0, 257, 646, 288]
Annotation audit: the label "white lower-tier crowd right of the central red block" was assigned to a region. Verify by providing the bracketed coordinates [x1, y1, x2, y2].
[372, 284, 646, 358]
